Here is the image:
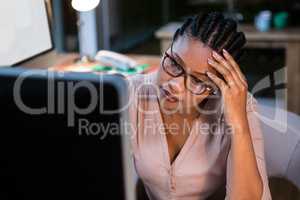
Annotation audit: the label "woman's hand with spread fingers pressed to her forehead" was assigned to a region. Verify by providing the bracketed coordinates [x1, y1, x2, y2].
[207, 49, 248, 124]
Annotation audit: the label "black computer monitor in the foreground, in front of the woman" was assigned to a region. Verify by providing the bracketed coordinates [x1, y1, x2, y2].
[0, 68, 136, 200]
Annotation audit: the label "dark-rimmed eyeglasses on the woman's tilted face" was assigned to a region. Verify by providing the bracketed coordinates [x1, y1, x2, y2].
[162, 52, 217, 95]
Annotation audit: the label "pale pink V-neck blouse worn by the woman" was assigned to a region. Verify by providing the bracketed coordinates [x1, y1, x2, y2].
[128, 71, 271, 200]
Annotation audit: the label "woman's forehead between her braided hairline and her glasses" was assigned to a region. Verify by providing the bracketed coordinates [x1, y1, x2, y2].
[172, 37, 212, 73]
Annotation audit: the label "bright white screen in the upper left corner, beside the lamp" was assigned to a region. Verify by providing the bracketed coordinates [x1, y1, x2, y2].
[0, 0, 52, 66]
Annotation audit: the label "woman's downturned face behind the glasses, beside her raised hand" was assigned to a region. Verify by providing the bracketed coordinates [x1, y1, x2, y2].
[157, 36, 216, 114]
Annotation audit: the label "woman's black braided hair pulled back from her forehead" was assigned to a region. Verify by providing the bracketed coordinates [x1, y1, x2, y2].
[173, 12, 246, 62]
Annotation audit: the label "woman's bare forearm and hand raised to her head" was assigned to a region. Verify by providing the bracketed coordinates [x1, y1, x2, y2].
[207, 51, 272, 199]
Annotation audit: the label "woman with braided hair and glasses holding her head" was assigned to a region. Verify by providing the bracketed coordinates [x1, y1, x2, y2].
[129, 12, 271, 200]
